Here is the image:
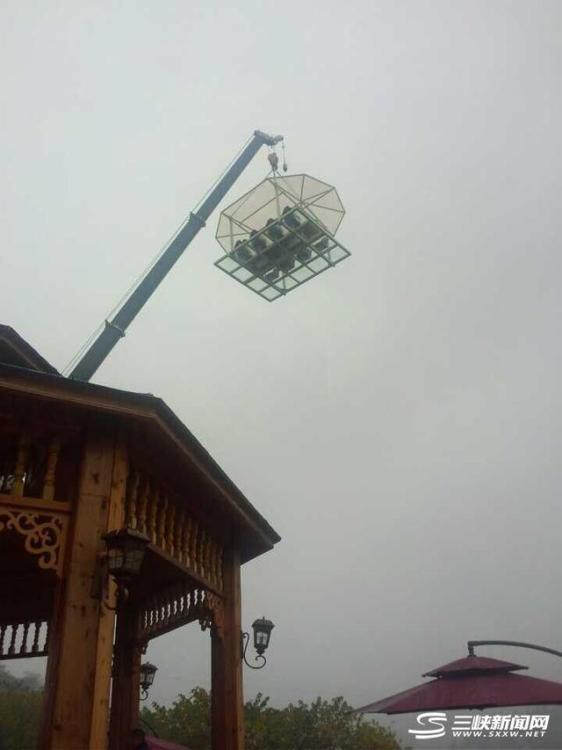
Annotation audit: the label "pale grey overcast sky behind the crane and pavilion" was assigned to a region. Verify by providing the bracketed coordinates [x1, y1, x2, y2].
[0, 0, 562, 740]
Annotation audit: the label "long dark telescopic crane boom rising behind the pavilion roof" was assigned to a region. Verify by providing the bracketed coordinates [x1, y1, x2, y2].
[70, 130, 283, 381]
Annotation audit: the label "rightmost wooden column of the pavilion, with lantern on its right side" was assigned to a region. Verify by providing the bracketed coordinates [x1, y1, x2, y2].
[211, 550, 244, 750]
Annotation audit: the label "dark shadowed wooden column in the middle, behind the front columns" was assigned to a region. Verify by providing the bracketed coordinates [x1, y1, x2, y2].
[109, 604, 141, 750]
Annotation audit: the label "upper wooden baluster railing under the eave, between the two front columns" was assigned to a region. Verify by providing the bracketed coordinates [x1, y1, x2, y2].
[125, 466, 223, 592]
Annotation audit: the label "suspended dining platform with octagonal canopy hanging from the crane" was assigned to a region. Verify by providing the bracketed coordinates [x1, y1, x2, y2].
[215, 174, 351, 302]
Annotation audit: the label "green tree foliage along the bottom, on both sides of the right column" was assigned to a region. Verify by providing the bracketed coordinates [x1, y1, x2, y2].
[141, 688, 400, 750]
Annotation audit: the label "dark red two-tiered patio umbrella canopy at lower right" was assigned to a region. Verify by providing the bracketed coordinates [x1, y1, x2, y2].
[357, 656, 562, 714]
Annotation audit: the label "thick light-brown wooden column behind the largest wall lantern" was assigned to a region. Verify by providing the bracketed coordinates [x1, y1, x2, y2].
[41, 423, 126, 750]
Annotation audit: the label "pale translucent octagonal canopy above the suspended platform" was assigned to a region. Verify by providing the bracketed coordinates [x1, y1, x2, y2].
[216, 174, 345, 253]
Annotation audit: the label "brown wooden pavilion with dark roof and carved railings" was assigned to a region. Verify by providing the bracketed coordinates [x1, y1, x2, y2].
[0, 326, 279, 750]
